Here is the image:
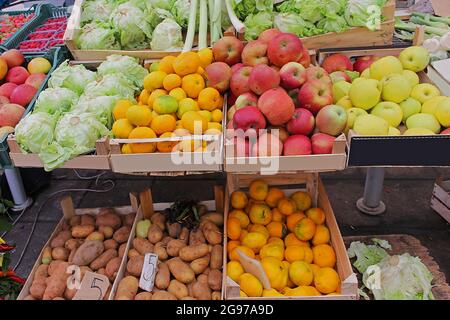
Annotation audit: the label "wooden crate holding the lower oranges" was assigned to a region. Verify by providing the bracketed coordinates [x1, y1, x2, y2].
[222, 173, 358, 300]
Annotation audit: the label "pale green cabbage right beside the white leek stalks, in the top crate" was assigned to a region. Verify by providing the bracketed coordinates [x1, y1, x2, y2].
[151, 19, 183, 51]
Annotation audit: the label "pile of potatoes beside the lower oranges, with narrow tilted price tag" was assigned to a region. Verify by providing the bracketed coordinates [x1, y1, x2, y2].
[115, 212, 223, 300]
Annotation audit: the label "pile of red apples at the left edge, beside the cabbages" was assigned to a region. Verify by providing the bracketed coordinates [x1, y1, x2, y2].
[0, 49, 51, 137]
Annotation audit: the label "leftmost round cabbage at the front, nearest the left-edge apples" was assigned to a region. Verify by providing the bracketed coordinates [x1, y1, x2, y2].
[15, 112, 58, 153]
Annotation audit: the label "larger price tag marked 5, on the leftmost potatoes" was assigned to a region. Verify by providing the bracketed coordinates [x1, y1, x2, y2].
[73, 272, 110, 300]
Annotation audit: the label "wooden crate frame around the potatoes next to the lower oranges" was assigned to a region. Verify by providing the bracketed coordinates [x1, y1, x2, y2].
[110, 186, 226, 300]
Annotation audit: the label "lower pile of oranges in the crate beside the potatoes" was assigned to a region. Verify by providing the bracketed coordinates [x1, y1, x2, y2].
[226, 180, 340, 297]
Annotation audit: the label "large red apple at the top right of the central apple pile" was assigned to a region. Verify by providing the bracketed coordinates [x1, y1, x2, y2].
[267, 33, 303, 68]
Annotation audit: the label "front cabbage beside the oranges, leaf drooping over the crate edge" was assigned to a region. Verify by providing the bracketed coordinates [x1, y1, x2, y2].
[39, 112, 110, 171]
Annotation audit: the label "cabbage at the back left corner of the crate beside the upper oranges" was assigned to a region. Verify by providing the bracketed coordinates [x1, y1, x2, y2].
[48, 60, 97, 95]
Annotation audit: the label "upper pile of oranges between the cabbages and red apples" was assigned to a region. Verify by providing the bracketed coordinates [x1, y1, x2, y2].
[112, 48, 223, 153]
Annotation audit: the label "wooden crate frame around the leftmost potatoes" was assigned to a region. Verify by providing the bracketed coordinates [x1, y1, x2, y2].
[17, 193, 141, 300]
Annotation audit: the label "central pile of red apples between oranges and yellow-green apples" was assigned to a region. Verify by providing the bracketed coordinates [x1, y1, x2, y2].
[213, 29, 347, 156]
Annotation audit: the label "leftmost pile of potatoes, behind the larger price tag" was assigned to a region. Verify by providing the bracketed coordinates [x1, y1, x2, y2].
[25, 208, 136, 300]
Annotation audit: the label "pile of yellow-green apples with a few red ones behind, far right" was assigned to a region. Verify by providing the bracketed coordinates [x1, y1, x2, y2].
[322, 46, 450, 136]
